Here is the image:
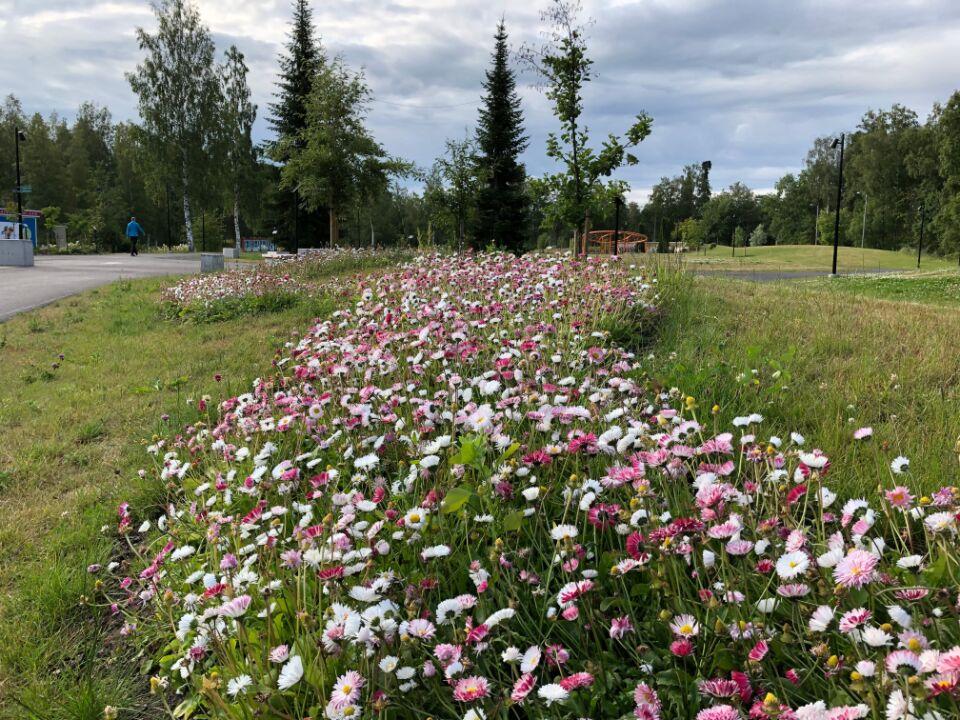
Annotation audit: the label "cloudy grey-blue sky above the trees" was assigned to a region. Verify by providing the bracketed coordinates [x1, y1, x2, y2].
[0, 0, 960, 200]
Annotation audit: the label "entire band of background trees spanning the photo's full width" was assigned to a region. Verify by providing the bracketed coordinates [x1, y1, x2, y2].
[0, 0, 960, 253]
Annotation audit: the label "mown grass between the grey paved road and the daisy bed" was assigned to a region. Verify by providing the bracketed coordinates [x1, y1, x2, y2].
[0, 279, 334, 720]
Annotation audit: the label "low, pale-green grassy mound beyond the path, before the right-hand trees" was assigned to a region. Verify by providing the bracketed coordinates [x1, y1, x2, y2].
[683, 245, 957, 272]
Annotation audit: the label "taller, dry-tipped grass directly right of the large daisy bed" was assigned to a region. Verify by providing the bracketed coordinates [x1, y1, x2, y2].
[649, 273, 960, 493]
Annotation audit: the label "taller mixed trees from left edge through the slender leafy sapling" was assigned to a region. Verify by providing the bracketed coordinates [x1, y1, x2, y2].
[0, 0, 651, 252]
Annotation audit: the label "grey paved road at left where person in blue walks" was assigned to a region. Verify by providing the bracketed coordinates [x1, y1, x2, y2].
[0, 253, 240, 322]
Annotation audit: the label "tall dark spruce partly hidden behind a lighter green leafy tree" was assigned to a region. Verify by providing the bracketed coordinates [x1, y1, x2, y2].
[268, 0, 325, 249]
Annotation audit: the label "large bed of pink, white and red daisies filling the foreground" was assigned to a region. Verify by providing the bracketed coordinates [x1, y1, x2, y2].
[106, 255, 960, 720]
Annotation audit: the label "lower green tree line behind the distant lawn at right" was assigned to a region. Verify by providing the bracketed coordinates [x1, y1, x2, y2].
[637, 98, 960, 254]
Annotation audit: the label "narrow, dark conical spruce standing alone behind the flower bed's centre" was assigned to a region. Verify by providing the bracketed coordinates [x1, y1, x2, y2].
[476, 19, 529, 253]
